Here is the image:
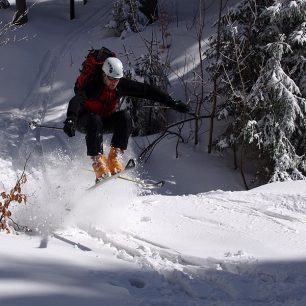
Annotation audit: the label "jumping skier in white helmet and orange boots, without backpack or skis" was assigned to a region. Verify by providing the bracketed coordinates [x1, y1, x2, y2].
[64, 57, 189, 182]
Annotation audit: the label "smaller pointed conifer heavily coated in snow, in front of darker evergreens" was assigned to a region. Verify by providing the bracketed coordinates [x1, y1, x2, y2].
[243, 35, 306, 181]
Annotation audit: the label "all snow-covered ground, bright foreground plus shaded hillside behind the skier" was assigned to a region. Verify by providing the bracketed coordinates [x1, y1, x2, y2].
[0, 0, 306, 306]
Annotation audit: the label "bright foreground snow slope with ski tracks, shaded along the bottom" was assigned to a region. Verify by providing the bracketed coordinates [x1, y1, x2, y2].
[0, 182, 306, 305]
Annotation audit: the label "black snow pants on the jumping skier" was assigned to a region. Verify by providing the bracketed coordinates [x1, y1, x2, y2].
[77, 110, 131, 156]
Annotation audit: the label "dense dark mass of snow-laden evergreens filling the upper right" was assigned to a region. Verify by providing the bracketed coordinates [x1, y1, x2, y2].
[206, 0, 306, 181]
